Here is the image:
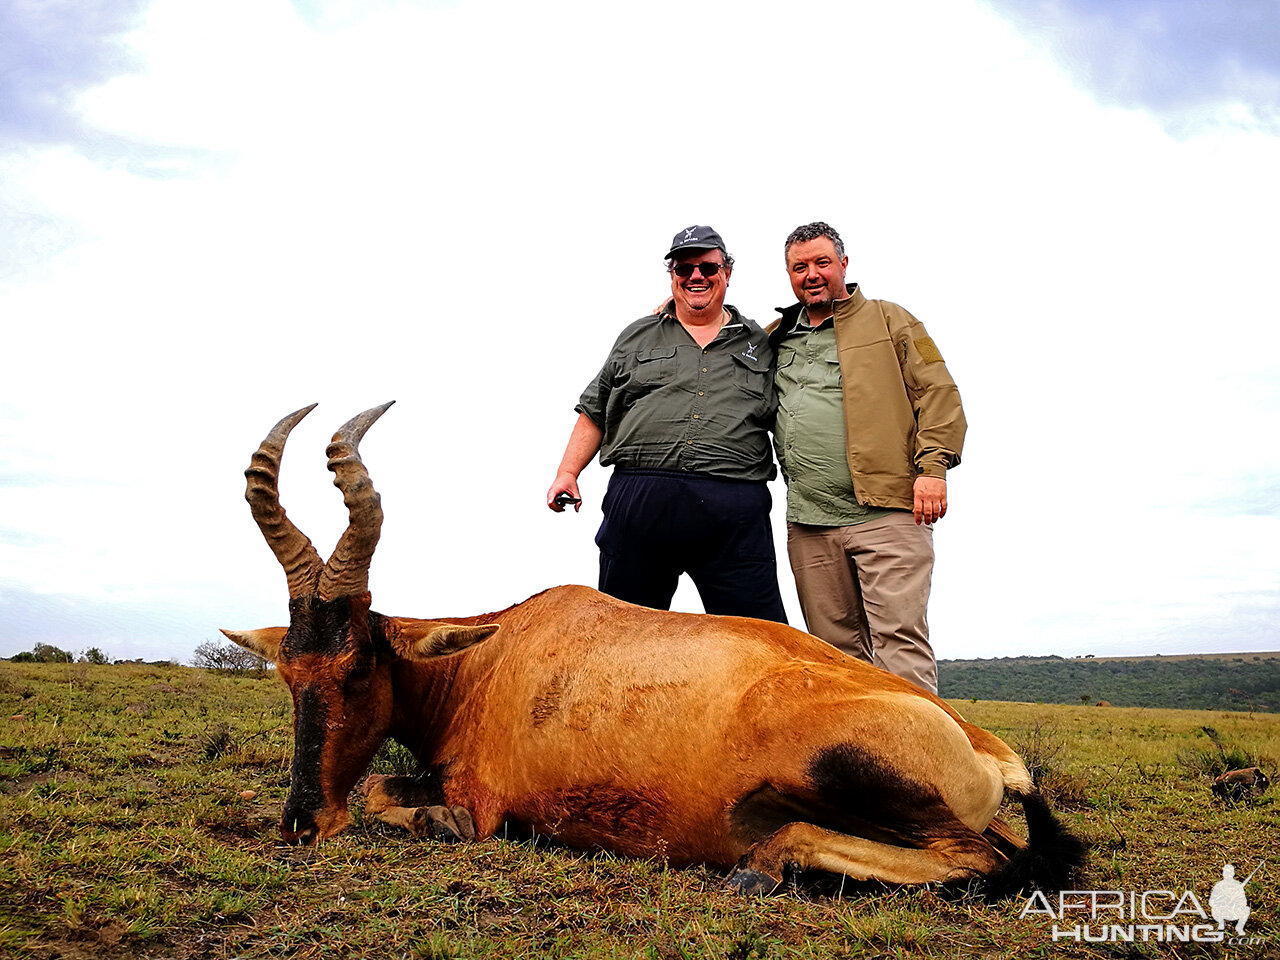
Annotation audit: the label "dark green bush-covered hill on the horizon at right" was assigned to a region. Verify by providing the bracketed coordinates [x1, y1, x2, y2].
[938, 653, 1280, 713]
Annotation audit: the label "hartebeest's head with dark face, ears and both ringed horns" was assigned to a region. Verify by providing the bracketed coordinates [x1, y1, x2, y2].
[223, 403, 498, 844]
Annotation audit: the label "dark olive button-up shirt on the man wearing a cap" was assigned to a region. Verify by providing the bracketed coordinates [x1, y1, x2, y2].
[575, 307, 777, 480]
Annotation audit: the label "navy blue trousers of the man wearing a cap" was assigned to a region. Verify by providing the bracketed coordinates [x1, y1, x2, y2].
[595, 470, 787, 623]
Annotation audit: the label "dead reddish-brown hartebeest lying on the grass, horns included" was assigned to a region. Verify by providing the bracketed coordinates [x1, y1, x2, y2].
[227, 403, 1083, 893]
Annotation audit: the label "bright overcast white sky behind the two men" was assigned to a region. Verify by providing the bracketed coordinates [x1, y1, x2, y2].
[0, 0, 1280, 660]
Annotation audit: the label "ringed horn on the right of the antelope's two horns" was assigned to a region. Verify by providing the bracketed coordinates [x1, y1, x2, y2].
[319, 401, 396, 600]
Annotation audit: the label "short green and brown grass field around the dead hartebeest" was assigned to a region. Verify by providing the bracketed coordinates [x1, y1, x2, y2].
[0, 662, 1280, 960]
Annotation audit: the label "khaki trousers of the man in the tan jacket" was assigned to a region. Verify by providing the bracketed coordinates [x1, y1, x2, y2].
[787, 511, 938, 694]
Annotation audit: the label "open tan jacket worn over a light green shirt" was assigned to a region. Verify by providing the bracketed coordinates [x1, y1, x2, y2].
[765, 284, 965, 509]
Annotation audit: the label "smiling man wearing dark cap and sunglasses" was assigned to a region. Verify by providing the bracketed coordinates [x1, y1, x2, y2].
[547, 227, 786, 623]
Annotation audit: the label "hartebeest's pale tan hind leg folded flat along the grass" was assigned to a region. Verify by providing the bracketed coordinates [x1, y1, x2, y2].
[728, 823, 1004, 896]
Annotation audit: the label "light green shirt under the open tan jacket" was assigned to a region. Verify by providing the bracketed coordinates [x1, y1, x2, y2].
[773, 316, 888, 526]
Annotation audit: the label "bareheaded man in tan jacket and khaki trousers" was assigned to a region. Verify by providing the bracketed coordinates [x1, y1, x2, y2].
[767, 223, 965, 692]
